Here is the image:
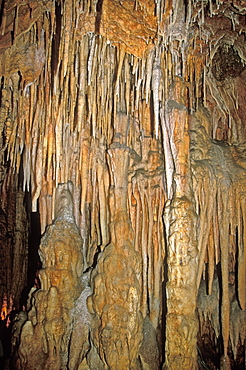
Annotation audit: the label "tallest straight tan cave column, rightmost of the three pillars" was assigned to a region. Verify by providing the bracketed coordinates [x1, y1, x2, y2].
[164, 80, 198, 370]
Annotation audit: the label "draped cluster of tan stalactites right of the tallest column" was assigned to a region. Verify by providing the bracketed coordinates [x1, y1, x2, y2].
[191, 112, 246, 367]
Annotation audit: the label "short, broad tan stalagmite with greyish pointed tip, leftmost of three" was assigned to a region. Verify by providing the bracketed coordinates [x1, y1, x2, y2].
[14, 185, 83, 369]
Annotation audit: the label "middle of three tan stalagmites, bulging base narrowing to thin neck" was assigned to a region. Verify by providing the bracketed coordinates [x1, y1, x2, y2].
[88, 114, 142, 370]
